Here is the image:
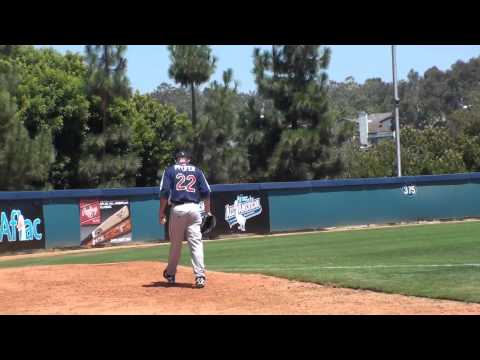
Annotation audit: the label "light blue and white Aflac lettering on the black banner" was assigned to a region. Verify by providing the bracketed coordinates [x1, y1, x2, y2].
[0, 209, 43, 241]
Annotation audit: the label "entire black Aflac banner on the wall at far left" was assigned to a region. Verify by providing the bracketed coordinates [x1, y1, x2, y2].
[0, 201, 45, 253]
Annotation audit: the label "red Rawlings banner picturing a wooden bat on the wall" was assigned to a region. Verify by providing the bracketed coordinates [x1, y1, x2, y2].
[80, 199, 132, 247]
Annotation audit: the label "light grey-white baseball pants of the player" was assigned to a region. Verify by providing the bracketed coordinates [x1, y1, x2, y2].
[167, 203, 205, 277]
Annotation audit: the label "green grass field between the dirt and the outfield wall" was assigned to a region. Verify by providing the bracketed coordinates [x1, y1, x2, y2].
[0, 222, 480, 303]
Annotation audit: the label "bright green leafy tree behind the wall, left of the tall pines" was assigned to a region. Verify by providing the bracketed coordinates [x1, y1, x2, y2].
[7, 48, 89, 188]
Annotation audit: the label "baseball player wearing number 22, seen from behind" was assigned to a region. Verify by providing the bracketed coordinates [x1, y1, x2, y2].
[159, 151, 211, 288]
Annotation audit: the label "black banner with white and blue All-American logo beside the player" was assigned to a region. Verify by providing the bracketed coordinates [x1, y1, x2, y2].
[211, 191, 270, 237]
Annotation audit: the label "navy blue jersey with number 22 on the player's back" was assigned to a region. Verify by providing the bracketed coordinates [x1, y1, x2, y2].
[160, 164, 211, 204]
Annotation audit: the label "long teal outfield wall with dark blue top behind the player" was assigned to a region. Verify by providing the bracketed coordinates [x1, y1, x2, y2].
[0, 173, 480, 252]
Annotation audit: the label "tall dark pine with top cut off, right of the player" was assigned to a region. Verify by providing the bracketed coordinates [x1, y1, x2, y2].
[254, 45, 340, 180]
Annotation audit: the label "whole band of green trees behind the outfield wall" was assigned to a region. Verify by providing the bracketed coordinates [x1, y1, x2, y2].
[4, 45, 480, 190]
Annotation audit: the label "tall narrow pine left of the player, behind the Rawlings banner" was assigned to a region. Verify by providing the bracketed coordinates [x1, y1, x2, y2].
[79, 45, 140, 187]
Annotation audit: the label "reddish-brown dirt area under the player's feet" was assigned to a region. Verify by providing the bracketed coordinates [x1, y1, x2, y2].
[0, 262, 480, 315]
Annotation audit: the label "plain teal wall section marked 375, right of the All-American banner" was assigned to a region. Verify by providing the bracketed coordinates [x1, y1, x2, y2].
[268, 174, 480, 232]
